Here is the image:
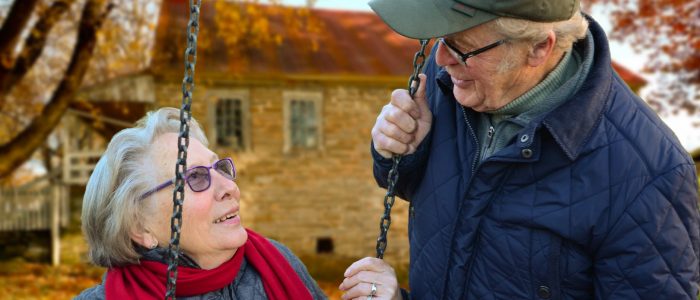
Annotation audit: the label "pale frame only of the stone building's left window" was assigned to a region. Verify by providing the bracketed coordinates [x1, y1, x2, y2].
[205, 89, 252, 151]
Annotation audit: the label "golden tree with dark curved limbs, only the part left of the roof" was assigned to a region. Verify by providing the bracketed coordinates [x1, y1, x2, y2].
[0, 0, 158, 178]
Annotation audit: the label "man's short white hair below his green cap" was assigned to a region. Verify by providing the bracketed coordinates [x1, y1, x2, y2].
[488, 11, 588, 71]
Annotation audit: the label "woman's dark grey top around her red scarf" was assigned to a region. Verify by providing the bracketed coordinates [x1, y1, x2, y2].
[75, 239, 327, 300]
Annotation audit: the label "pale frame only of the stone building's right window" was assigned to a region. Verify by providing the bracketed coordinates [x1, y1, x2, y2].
[282, 91, 323, 153]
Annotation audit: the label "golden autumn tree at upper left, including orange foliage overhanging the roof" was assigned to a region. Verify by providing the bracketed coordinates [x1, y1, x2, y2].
[0, 0, 321, 178]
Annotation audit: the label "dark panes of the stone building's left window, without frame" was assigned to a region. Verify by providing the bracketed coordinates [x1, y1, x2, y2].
[216, 99, 246, 149]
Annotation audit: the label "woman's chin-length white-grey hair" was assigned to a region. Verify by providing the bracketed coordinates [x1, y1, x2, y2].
[81, 107, 208, 267]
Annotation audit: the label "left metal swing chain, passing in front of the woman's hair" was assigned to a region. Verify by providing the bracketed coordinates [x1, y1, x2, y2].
[165, 0, 202, 299]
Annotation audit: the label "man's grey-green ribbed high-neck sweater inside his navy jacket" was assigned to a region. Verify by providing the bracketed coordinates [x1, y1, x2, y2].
[477, 33, 593, 161]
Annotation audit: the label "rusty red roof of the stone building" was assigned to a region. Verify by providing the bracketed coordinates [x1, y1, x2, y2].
[152, 0, 646, 86]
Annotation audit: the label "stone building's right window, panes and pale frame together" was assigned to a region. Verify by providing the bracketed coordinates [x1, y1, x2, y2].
[284, 92, 322, 152]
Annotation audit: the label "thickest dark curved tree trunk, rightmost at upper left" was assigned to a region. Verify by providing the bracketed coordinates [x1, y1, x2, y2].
[0, 0, 111, 178]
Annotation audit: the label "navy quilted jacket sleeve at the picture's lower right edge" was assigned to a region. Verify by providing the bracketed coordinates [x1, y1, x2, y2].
[594, 164, 700, 299]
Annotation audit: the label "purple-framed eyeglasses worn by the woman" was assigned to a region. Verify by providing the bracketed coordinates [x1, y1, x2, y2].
[141, 157, 236, 199]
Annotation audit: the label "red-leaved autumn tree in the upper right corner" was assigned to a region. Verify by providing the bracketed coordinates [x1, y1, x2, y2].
[589, 0, 700, 114]
